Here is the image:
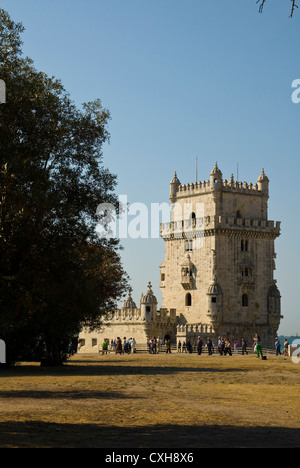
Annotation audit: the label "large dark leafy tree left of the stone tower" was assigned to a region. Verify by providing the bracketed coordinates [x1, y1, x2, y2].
[0, 9, 128, 365]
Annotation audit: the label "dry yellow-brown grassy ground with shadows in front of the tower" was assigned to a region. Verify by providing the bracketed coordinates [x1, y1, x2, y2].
[0, 353, 300, 449]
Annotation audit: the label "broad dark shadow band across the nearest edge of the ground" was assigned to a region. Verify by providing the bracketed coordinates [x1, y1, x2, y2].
[0, 421, 300, 450]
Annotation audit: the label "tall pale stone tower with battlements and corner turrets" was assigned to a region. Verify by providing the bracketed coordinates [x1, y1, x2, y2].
[160, 163, 282, 348]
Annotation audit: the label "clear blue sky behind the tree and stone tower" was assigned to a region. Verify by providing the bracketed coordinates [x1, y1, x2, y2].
[1, 0, 300, 335]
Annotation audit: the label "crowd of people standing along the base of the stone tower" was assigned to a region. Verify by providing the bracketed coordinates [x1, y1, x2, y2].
[102, 333, 288, 358]
